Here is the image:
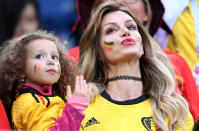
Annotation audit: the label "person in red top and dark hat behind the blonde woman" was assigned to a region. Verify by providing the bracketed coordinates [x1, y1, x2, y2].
[68, 0, 199, 122]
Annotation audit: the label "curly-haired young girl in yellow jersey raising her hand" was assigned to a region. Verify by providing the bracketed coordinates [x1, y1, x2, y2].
[0, 31, 91, 131]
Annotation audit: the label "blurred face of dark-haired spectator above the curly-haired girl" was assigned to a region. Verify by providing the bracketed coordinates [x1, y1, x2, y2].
[14, 3, 39, 36]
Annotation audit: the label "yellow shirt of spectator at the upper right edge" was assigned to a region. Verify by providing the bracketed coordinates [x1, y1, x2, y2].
[168, 0, 199, 71]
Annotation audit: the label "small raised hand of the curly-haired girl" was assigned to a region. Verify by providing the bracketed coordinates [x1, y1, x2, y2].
[67, 75, 92, 99]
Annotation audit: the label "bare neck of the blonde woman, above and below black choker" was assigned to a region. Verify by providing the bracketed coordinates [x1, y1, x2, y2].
[105, 61, 143, 101]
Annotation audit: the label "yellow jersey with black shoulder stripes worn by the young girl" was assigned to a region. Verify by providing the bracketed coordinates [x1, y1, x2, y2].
[12, 89, 65, 131]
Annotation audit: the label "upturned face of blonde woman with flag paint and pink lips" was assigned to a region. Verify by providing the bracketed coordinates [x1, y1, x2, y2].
[100, 11, 143, 64]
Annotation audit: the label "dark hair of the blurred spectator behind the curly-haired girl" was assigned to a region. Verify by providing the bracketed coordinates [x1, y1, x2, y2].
[0, 0, 39, 46]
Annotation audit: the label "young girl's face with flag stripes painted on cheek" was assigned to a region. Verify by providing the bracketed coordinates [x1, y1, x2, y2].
[25, 39, 61, 87]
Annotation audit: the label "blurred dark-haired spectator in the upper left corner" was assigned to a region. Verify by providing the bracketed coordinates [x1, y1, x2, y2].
[0, 0, 40, 45]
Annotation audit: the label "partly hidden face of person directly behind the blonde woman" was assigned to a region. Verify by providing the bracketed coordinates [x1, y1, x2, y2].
[106, 0, 149, 24]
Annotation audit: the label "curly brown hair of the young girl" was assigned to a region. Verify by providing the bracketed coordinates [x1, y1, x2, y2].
[0, 30, 76, 122]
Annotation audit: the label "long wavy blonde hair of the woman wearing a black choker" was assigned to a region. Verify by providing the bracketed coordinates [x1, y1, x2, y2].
[78, 2, 189, 131]
